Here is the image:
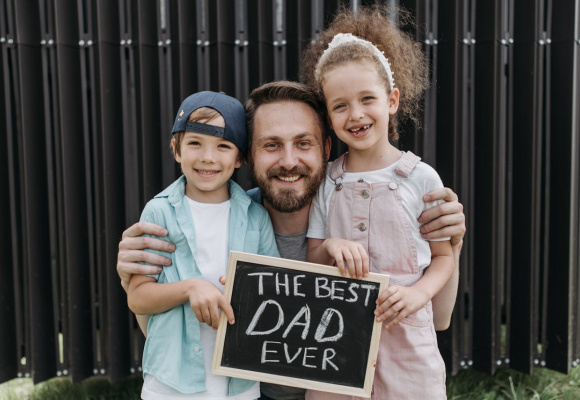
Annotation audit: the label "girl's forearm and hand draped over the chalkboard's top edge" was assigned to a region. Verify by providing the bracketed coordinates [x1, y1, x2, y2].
[306, 238, 370, 279]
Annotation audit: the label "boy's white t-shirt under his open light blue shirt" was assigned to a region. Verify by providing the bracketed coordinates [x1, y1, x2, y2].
[141, 197, 260, 400]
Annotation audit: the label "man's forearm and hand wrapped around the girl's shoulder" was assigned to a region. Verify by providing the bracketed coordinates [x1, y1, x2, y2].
[418, 188, 466, 331]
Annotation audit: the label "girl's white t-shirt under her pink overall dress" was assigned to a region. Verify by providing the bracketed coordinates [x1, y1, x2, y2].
[307, 158, 450, 271]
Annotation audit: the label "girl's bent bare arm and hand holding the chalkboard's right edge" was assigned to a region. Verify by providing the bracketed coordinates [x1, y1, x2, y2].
[375, 241, 455, 329]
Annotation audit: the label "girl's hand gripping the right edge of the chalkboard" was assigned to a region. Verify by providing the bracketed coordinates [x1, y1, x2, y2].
[375, 285, 429, 329]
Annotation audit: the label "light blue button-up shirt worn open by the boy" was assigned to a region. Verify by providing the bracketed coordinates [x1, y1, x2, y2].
[141, 176, 279, 396]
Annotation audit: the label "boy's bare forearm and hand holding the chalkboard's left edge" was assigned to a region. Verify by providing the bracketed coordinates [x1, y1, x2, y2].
[127, 275, 234, 328]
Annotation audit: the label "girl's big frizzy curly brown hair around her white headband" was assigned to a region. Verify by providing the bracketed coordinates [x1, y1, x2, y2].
[300, 4, 429, 140]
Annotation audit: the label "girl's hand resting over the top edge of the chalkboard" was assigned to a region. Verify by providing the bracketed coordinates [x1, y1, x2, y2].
[323, 238, 369, 279]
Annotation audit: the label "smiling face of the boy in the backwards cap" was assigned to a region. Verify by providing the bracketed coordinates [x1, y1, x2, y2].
[172, 116, 242, 203]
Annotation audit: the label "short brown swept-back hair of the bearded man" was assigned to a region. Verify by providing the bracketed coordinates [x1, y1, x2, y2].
[245, 81, 328, 154]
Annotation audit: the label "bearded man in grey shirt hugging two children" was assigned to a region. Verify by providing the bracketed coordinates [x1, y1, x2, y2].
[117, 81, 465, 400]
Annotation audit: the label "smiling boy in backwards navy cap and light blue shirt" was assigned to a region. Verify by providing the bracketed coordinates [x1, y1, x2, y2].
[128, 92, 279, 400]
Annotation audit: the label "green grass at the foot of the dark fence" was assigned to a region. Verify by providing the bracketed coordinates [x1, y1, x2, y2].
[0, 367, 580, 400]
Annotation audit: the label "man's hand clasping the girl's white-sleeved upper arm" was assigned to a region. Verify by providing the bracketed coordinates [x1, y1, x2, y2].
[418, 188, 465, 246]
